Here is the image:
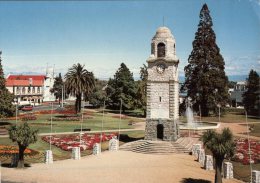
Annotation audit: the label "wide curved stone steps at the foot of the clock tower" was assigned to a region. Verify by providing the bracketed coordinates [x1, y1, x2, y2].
[120, 140, 190, 154]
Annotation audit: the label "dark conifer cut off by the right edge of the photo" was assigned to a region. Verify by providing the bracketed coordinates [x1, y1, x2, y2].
[243, 70, 260, 116]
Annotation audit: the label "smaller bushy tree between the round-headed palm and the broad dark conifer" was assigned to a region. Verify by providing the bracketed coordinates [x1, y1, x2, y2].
[87, 79, 107, 107]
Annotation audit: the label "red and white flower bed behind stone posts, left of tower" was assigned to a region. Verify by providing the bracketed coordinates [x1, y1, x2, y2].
[42, 133, 117, 151]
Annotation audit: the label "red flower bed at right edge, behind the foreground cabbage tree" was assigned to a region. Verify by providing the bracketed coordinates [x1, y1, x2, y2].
[234, 138, 260, 165]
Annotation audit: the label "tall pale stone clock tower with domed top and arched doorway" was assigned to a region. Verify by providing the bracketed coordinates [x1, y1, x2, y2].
[145, 27, 179, 141]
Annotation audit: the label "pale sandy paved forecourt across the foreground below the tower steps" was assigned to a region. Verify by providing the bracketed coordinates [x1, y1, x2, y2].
[2, 151, 243, 183]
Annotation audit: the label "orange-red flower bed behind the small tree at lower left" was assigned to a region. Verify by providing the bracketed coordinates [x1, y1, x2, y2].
[0, 145, 38, 156]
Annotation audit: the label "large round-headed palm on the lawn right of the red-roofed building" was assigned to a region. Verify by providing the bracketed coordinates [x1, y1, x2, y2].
[65, 63, 95, 113]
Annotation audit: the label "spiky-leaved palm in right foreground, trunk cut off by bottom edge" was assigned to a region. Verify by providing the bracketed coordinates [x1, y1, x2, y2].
[201, 128, 235, 183]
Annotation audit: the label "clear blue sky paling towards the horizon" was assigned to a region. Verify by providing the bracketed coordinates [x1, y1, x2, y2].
[0, 0, 260, 78]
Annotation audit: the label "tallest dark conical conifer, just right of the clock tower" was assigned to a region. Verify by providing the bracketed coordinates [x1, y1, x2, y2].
[184, 4, 229, 116]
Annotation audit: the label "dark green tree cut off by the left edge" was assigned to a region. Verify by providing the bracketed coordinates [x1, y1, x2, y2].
[0, 51, 15, 118]
